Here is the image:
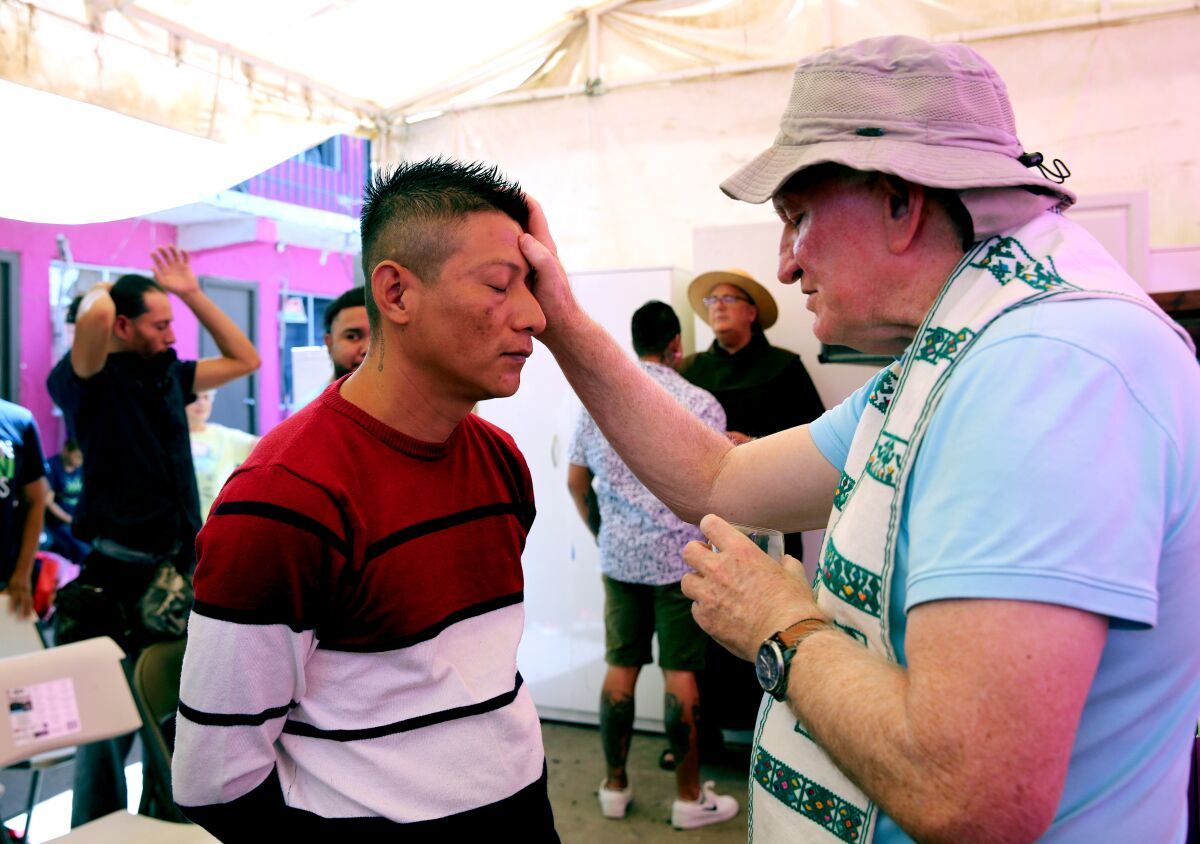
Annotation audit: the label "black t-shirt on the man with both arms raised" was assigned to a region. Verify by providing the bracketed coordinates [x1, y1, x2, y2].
[46, 349, 200, 553]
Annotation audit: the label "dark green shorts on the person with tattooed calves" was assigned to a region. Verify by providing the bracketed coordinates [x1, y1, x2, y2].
[602, 575, 707, 671]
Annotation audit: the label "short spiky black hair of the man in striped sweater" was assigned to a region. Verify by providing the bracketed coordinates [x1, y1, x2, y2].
[359, 157, 529, 335]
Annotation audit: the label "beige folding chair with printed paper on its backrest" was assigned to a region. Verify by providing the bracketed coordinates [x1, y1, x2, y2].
[0, 636, 216, 844]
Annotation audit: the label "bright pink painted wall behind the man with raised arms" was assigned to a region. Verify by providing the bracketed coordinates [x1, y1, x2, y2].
[0, 219, 355, 451]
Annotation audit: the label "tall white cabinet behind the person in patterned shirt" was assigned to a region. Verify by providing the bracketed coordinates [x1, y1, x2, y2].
[479, 269, 691, 731]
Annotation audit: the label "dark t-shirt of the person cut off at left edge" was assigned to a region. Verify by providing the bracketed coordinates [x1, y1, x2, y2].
[0, 399, 46, 583]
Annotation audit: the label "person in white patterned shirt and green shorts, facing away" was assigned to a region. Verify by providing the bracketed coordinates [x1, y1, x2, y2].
[568, 301, 738, 828]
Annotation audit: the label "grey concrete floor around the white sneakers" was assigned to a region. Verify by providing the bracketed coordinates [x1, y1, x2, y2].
[541, 722, 750, 844]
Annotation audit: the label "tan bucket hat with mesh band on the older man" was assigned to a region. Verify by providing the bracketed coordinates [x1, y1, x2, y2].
[721, 35, 1075, 209]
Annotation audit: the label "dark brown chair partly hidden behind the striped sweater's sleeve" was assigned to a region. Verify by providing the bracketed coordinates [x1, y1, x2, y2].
[133, 639, 187, 824]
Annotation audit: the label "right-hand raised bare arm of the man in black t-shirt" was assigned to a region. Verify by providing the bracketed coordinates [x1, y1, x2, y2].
[150, 246, 259, 391]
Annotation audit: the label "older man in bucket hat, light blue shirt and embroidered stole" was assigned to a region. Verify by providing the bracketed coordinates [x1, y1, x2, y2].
[522, 37, 1200, 842]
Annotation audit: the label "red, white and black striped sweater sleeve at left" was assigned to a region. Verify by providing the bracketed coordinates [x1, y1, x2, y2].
[173, 467, 347, 840]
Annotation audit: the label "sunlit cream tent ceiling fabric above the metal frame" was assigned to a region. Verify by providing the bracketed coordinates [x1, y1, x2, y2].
[0, 0, 1180, 146]
